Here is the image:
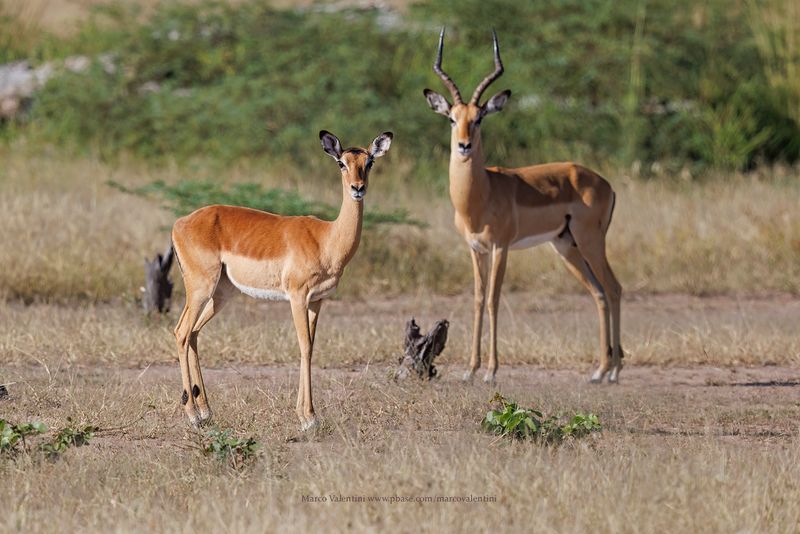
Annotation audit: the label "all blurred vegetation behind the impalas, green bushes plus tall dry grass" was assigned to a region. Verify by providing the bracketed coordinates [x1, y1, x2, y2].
[0, 0, 800, 301]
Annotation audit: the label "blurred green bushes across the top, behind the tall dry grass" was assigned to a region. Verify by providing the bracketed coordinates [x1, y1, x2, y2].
[0, 0, 800, 176]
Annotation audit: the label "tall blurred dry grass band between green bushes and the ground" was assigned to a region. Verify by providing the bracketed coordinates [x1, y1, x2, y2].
[0, 143, 800, 302]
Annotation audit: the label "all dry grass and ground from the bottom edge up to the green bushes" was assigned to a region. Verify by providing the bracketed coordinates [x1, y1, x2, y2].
[0, 5, 800, 532]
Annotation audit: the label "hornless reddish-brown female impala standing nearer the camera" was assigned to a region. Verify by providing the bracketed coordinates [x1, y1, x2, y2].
[172, 130, 392, 430]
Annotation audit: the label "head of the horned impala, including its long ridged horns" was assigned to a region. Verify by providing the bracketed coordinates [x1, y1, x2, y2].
[423, 28, 511, 160]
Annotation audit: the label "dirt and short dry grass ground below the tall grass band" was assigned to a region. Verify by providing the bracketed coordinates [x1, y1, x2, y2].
[0, 294, 800, 532]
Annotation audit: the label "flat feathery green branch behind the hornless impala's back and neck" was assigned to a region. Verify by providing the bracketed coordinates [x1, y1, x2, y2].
[106, 180, 425, 228]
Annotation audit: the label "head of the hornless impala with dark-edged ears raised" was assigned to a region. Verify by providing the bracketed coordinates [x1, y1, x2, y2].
[319, 130, 393, 202]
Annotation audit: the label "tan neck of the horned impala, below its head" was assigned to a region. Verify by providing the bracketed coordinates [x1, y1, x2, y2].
[450, 134, 490, 231]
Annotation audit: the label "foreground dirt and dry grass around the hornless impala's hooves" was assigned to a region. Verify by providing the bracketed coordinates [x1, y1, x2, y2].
[0, 358, 800, 532]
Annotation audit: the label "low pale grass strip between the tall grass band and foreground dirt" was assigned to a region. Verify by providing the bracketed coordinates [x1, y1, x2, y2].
[0, 293, 800, 372]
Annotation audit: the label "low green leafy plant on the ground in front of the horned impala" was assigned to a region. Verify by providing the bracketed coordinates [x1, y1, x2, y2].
[481, 393, 602, 445]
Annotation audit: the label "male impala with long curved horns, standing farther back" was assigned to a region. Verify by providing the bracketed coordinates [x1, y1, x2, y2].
[424, 28, 623, 382]
